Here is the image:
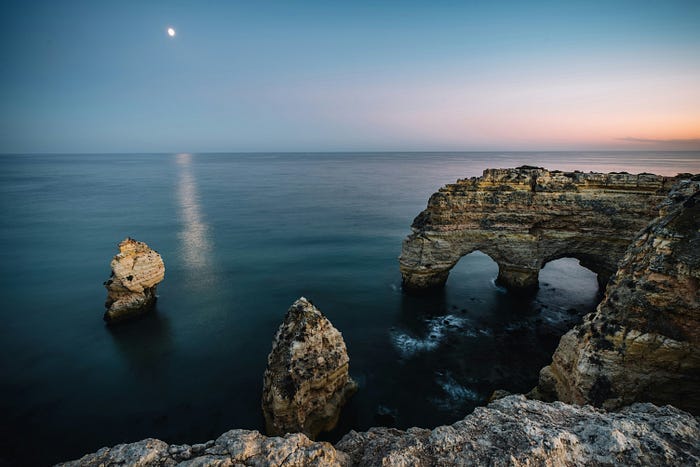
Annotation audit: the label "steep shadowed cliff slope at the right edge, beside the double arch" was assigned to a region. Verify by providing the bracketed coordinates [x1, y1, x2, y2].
[533, 176, 700, 414]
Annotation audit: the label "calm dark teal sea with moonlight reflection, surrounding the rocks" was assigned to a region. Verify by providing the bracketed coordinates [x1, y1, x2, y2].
[0, 152, 700, 464]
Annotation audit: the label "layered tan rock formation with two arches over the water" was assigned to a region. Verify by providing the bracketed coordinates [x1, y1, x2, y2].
[399, 166, 675, 291]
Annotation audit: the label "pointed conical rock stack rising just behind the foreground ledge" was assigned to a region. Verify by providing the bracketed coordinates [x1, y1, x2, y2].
[262, 297, 357, 439]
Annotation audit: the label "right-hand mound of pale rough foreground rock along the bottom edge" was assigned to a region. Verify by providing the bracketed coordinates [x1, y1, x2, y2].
[336, 396, 700, 466]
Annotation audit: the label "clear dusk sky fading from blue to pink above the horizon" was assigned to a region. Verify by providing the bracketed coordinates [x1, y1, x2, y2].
[0, 0, 700, 153]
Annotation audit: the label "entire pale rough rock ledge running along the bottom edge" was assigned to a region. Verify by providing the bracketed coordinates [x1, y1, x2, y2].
[63, 396, 700, 466]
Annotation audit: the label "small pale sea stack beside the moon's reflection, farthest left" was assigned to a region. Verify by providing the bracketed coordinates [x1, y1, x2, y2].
[104, 238, 165, 322]
